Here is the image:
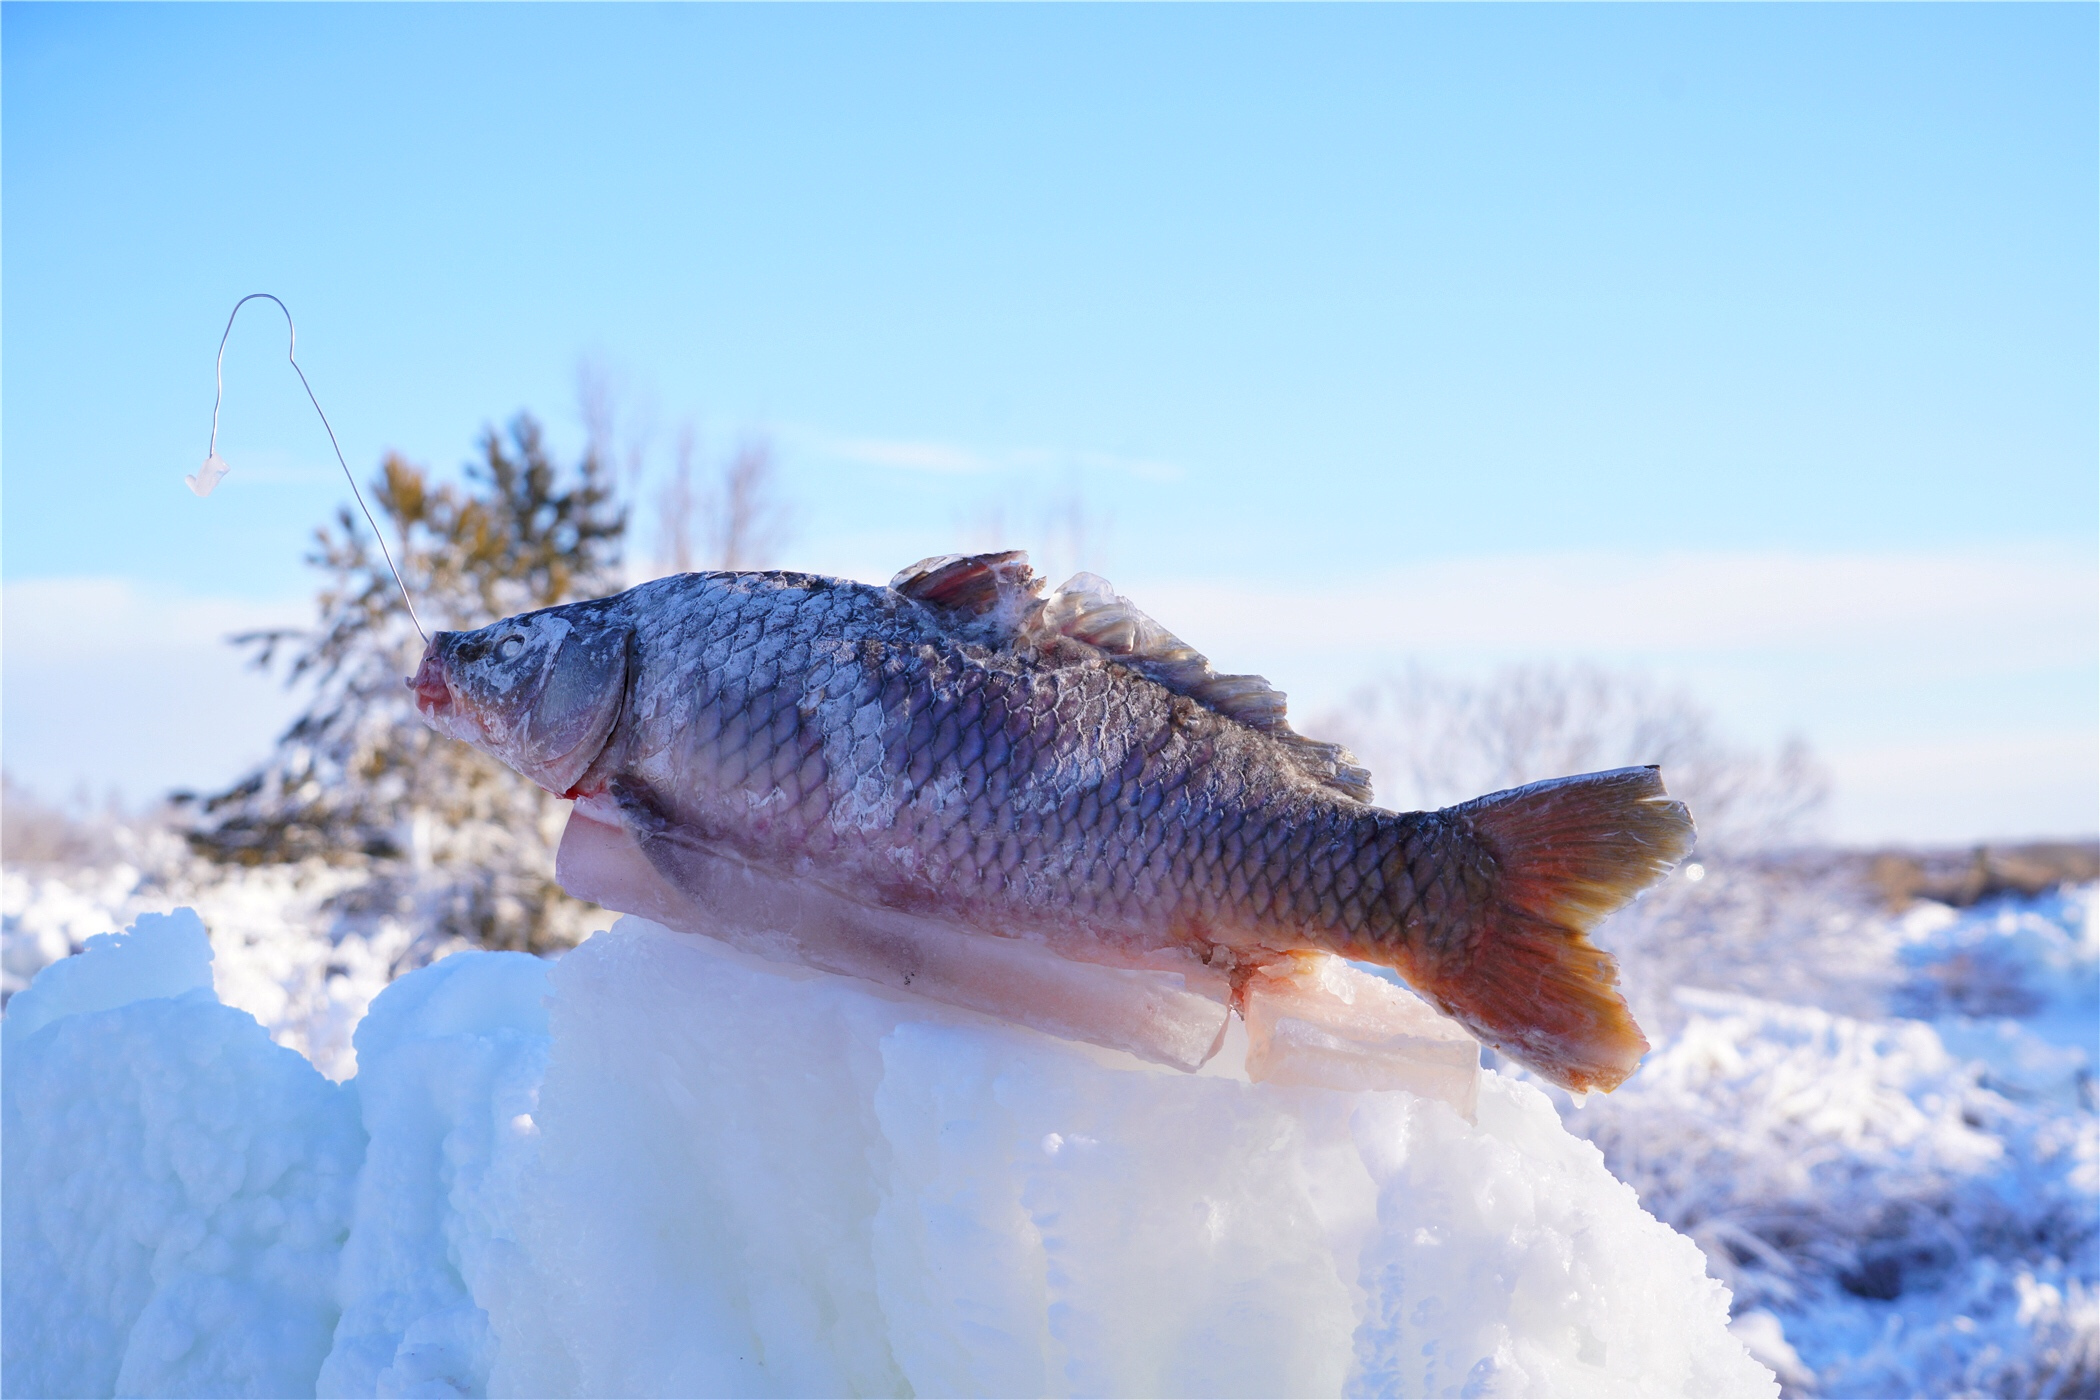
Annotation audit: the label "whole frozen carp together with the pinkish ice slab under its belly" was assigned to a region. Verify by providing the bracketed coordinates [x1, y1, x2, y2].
[407, 550, 1695, 1094]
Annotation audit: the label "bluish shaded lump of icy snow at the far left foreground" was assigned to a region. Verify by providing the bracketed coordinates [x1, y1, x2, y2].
[0, 911, 363, 1396]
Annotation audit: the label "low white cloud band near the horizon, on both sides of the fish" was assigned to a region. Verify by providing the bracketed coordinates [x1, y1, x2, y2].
[12, 535, 2100, 842]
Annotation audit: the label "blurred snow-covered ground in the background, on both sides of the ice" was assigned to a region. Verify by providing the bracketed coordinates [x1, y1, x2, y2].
[0, 835, 2100, 1396]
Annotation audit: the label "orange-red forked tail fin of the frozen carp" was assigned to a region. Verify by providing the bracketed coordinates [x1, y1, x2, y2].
[1401, 768, 1693, 1091]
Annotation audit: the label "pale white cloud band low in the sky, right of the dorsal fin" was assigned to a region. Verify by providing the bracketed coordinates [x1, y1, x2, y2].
[1117, 546, 2100, 844]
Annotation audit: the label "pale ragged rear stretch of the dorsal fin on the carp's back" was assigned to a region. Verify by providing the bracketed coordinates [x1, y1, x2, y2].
[1042, 573, 1371, 802]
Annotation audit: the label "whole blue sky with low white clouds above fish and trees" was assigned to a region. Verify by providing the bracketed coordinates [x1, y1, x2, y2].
[0, 4, 2100, 840]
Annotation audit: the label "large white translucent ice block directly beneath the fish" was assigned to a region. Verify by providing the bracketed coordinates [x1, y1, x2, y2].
[451, 919, 1775, 1396]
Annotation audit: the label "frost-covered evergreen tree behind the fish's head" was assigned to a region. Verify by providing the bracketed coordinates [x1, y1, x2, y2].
[189, 416, 626, 953]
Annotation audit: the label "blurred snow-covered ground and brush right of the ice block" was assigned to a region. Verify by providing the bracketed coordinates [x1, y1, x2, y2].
[1569, 888, 2100, 1396]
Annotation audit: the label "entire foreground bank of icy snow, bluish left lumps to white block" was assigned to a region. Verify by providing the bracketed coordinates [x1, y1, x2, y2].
[4, 902, 1772, 1396]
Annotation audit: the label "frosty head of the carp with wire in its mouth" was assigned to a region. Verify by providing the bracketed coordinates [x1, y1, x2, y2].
[407, 609, 632, 796]
